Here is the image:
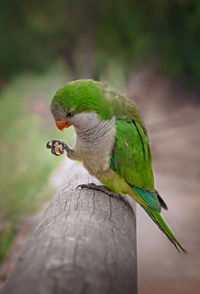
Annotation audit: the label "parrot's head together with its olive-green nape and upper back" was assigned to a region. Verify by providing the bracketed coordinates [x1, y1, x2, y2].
[51, 79, 147, 134]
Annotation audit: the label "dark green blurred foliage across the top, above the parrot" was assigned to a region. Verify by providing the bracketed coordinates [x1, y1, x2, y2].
[0, 0, 200, 84]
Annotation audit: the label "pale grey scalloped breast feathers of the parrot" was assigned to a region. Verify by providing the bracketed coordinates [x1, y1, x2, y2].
[74, 112, 116, 176]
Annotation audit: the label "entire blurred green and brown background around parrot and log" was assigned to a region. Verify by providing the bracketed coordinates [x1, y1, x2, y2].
[0, 0, 200, 294]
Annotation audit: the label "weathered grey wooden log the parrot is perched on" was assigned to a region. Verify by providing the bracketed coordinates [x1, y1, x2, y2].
[1, 164, 137, 294]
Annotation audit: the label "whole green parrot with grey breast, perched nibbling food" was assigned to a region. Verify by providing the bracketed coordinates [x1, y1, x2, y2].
[47, 79, 186, 253]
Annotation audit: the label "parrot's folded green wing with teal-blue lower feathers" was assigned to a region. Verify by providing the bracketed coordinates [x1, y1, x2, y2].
[110, 119, 161, 211]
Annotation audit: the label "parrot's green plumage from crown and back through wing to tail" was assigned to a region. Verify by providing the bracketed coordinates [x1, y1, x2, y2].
[51, 80, 186, 252]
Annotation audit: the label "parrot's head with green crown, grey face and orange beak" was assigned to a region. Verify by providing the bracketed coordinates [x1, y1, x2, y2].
[51, 80, 110, 130]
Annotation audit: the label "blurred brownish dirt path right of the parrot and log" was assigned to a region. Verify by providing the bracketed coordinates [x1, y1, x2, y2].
[131, 72, 200, 294]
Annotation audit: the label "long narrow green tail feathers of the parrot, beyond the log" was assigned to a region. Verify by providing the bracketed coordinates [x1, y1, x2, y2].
[143, 206, 187, 254]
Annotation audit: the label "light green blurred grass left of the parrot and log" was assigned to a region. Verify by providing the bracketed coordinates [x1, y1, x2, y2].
[0, 67, 72, 260]
